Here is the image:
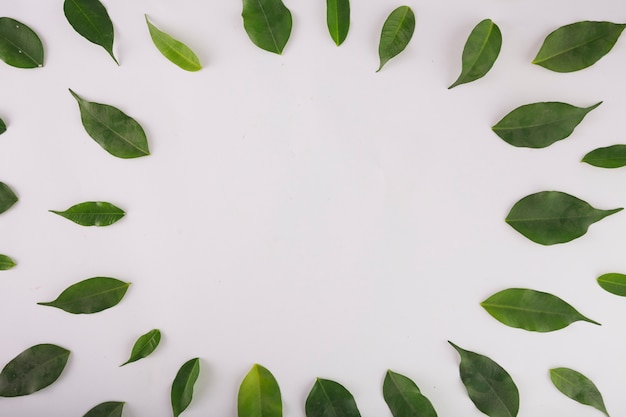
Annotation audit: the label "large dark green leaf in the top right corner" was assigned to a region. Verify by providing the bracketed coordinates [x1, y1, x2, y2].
[533, 21, 626, 72]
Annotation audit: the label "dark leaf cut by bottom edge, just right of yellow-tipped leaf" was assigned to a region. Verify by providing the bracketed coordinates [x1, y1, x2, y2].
[304, 378, 361, 417]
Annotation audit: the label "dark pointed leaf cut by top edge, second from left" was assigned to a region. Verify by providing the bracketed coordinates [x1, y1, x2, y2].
[63, 0, 119, 65]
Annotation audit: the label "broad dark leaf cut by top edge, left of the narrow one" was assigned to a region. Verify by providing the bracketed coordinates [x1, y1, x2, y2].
[241, 0, 292, 55]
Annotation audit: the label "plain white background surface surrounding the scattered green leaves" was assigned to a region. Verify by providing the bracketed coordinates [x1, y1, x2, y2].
[0, 0, 626, 417]
